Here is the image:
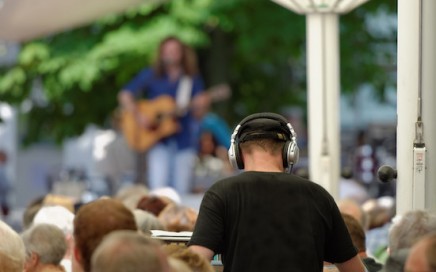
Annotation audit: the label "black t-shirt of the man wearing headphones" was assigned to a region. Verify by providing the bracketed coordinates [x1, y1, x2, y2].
[190, 172, 357, 272]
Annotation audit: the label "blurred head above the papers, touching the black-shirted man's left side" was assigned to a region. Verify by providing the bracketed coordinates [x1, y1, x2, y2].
[158, 204, 198, 232]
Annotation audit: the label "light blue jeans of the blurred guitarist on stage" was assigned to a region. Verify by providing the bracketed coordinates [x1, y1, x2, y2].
[147, 142, 195, 194]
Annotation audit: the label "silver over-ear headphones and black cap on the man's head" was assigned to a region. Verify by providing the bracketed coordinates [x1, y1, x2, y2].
[228, 112, 299, 171]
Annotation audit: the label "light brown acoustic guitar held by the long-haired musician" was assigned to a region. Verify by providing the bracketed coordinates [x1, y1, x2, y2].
[121, 84, 231, 152]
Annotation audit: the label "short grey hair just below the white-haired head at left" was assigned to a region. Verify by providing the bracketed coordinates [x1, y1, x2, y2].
[21, 224, 67, 265]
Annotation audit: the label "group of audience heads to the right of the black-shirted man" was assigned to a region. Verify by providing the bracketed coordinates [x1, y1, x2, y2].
[336, 194, 436, 272]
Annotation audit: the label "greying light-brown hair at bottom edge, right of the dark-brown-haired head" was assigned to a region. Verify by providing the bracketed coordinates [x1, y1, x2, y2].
[91, 231, 169, 272]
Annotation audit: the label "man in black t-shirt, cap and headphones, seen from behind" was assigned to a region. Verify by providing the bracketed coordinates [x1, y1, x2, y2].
[189, 113, 365, 272]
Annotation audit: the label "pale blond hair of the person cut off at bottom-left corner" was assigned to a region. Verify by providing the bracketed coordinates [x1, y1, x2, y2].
[0, 220, 25, 272]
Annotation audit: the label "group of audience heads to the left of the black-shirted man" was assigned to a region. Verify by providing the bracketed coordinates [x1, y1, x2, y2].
[0, 185, 215, 272]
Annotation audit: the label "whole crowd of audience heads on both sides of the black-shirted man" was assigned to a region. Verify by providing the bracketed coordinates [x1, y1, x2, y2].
[0, 152, 436, 272]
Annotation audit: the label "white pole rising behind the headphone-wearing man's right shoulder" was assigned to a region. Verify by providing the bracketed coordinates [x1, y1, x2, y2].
[306, 13, 340, 199]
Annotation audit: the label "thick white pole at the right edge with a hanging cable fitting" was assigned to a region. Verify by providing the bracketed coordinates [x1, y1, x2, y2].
[397, 0, 436, 214]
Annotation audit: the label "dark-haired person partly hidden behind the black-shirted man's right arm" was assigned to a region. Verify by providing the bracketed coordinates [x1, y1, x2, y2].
[342, 214, 382, 272]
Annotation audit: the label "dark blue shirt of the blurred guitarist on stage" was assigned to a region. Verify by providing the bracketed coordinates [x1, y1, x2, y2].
[123, 68, 204, 150]
